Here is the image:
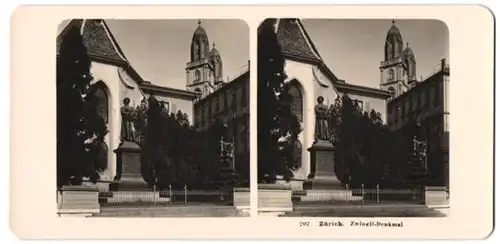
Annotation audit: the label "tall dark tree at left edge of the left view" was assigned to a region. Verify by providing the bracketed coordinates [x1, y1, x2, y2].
[56, 27, 108, 187]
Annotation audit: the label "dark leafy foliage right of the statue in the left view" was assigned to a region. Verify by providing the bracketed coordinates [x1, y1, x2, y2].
[135, 96, 234, 190]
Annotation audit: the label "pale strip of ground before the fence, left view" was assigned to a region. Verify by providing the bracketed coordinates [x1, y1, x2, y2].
[92, 205, 248, 218]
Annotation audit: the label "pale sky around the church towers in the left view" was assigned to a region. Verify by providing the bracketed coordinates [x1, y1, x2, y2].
[59, 19, 250, 89]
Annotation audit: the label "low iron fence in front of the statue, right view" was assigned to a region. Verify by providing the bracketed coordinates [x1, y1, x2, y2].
[292, 187, 425, 205]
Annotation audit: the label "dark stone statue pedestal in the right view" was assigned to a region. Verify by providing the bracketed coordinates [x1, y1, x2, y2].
[303, 140, 343, 189]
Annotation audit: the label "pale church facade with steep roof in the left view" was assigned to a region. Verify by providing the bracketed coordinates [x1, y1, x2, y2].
[56, 19, 196, 181]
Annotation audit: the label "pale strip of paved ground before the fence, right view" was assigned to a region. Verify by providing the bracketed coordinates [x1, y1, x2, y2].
[281, 204, 447, 217]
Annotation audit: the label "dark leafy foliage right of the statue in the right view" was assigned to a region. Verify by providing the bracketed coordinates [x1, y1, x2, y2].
[330, 94, 426, 188]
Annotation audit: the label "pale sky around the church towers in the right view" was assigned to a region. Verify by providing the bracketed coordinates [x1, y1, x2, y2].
[301, 19, 449, 88]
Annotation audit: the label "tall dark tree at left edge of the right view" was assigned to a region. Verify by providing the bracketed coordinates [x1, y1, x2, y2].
[257, 19, 301, 182]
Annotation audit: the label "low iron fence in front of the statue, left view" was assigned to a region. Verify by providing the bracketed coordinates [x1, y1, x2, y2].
[99, 189, 233, 207]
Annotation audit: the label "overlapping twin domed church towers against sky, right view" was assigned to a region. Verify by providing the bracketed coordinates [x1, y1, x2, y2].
[380, 20, 415, 97]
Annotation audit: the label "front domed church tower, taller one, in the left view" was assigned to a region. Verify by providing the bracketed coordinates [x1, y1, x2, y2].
[186, 20, 215, 97]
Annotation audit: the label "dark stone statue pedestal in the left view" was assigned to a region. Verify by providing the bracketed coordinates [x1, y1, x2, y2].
[110, 141, 148, 191]
